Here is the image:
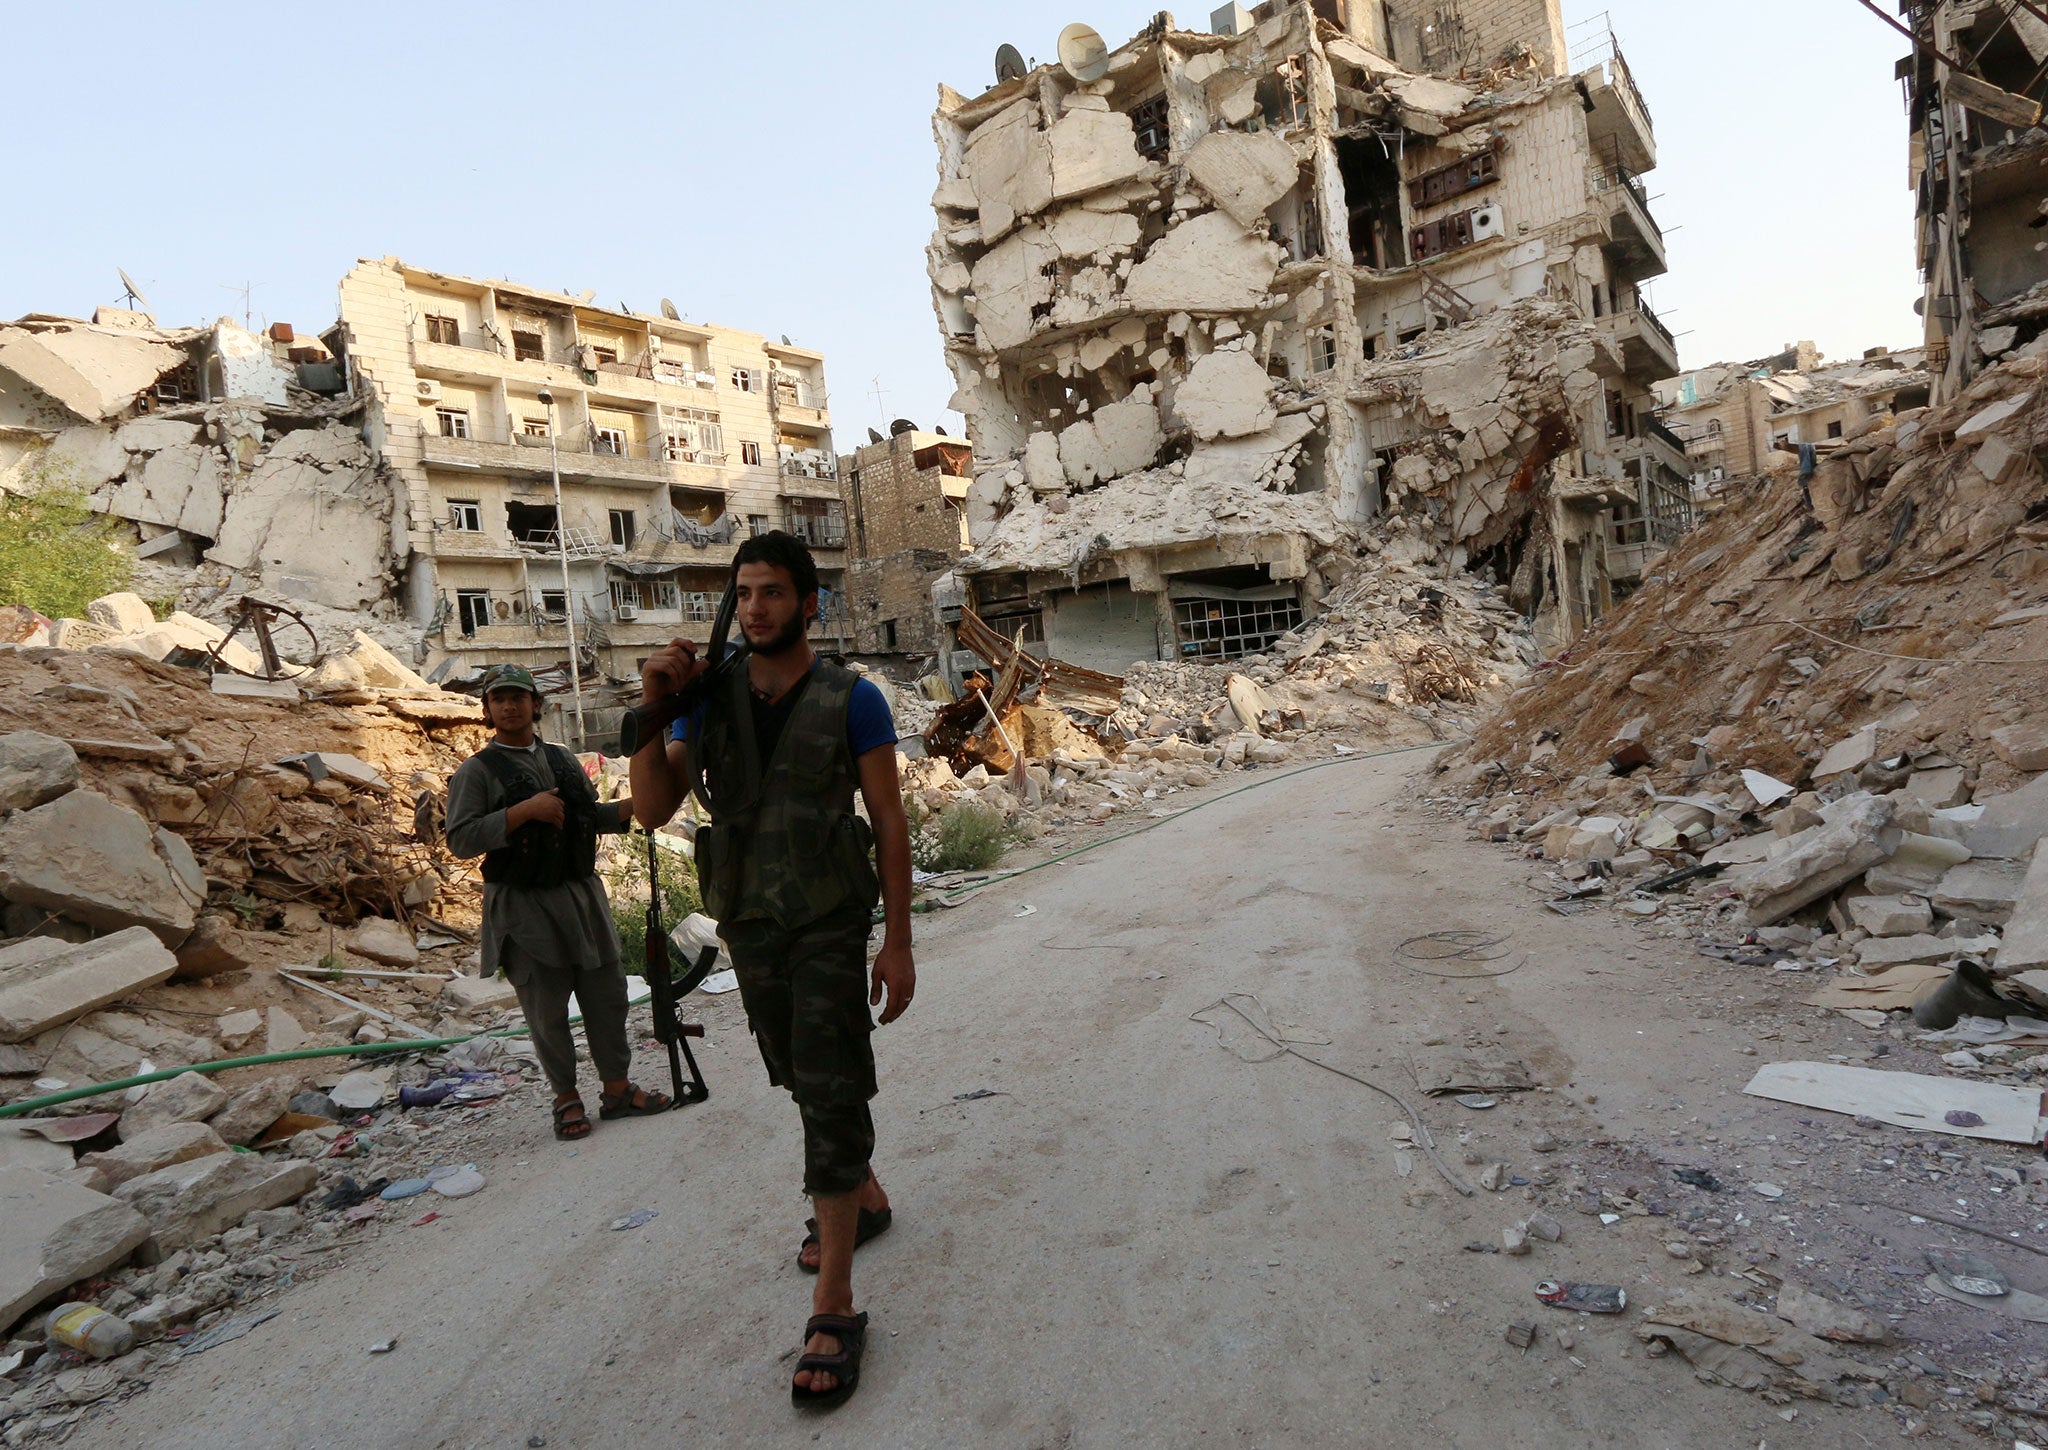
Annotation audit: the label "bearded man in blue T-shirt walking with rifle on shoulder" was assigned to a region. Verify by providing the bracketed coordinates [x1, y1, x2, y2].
[625, 532, 918, 1407]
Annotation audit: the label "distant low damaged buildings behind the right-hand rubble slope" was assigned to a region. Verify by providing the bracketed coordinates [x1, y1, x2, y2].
[1657, 342, 1927, 498]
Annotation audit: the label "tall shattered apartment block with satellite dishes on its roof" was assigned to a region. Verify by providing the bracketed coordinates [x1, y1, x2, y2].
[930, 0, 1690, 670]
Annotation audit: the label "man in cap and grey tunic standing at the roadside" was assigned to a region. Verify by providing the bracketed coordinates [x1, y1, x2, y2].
[446, 666, 676, 1139]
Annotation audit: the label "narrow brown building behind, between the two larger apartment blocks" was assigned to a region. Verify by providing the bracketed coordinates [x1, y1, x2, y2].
[840, 418, 973, 655]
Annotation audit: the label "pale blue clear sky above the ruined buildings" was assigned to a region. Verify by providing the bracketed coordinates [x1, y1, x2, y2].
[0, 0, 1919, 436]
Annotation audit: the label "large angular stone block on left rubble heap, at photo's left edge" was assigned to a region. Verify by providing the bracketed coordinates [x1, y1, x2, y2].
[0, 791, 195, 946]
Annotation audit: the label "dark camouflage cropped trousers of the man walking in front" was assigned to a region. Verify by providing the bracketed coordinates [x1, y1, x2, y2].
[725, 909, 874, 1194]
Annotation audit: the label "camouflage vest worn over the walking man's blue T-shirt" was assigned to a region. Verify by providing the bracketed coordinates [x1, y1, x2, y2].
[696, 662, 881, 930]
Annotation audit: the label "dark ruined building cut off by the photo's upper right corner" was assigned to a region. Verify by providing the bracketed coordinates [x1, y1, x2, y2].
[1898, 0, 2048, 401]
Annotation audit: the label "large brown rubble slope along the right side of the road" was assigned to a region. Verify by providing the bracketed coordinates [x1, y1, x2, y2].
[1442, 346, 2048, 1073]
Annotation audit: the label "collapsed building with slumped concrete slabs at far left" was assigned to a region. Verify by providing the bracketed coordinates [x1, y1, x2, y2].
[0, 307, 393, 612]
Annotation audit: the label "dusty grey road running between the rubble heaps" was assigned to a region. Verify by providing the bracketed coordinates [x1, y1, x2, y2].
[59, 756, 1939, 1450]
